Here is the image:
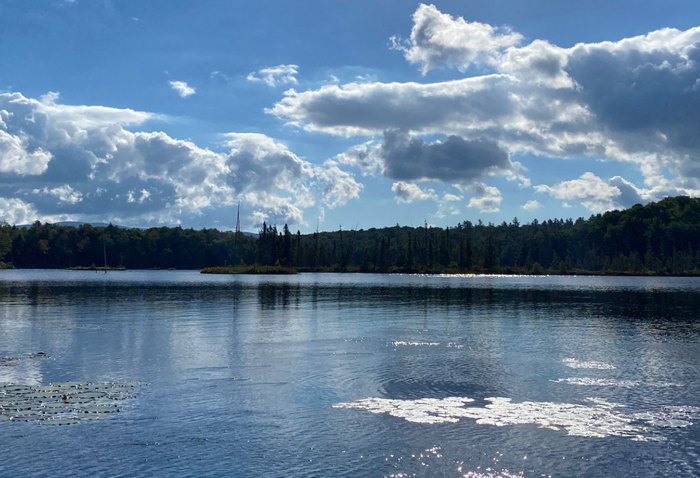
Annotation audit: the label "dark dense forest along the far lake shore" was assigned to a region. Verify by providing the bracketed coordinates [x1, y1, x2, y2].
[0, 197, 700, 275]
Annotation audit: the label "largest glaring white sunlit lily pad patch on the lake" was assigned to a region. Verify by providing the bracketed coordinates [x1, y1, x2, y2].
[333, 397, 700, 441]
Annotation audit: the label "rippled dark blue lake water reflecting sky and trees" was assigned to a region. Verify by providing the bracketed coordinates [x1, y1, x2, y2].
[0, 271, 700, 478]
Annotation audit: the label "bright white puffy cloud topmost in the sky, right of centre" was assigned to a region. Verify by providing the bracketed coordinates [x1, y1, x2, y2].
[391, 4, 523, 74]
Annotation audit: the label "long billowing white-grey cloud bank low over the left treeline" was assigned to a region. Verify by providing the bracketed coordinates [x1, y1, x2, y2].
[0, 93, 361, 230]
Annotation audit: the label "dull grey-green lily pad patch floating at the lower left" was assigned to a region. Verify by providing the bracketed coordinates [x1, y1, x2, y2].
[0, 382, 140, 425]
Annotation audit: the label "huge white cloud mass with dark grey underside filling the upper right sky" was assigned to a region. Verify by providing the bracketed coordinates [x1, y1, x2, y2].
[268, 5, 700, 202]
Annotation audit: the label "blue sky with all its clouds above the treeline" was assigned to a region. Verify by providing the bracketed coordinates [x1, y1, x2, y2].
[0, 0, 700, 232]
